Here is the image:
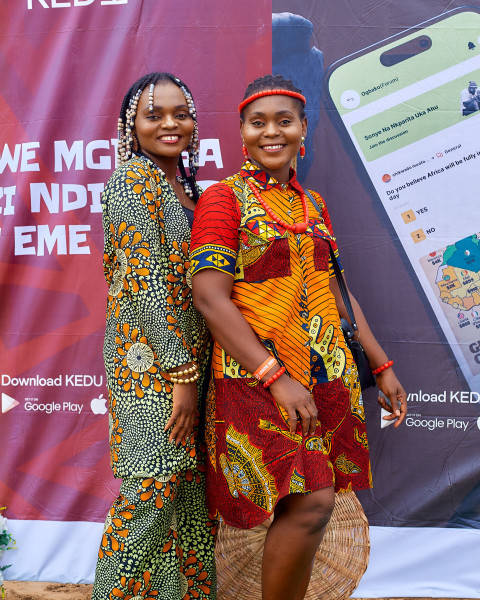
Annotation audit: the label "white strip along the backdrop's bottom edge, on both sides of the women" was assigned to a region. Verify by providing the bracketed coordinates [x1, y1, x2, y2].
[3, 520, 480, 598]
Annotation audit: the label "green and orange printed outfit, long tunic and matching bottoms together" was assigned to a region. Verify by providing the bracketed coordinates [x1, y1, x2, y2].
[92, 157, 217, 600]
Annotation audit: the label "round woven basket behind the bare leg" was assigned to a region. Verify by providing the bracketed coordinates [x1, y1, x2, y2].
[216, 492, 370, 600]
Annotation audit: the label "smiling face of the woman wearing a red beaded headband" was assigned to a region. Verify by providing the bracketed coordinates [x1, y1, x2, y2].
[240, 95, 307, 181]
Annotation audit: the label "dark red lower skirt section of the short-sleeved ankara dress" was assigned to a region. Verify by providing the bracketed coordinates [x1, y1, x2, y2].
[207, 376, 371, 528]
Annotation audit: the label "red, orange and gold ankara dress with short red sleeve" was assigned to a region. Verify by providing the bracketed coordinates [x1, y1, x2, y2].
[190, 161, 370, 528]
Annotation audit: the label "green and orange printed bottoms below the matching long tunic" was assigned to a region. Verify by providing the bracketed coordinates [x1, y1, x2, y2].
[92, 472, 217, 600]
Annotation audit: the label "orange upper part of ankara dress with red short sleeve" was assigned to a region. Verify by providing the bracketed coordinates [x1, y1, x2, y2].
[191, 161, 351, 386]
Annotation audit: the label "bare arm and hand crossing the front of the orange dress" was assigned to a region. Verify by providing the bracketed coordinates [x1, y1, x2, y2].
[193, 269, 317, 436]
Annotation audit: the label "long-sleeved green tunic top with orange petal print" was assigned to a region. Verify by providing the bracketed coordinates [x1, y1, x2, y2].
[102, 157, 209, 477]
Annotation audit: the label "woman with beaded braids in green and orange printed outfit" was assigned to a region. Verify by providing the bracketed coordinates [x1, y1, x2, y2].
[92, 73, 216, 600]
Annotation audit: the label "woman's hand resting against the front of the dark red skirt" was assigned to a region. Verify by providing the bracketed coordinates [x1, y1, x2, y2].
[268, 374, 318, 436]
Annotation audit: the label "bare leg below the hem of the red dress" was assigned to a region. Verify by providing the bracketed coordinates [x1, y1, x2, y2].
[262, 487, 335, 600]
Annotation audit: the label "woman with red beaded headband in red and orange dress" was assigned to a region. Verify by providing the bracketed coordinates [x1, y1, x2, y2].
[190, 76, 406, 600]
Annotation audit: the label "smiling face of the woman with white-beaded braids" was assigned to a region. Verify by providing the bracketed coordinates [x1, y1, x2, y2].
[134, 81, 194, 167]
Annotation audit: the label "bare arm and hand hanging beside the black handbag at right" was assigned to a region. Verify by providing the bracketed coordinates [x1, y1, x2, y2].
[330, 277, 407, 427]
